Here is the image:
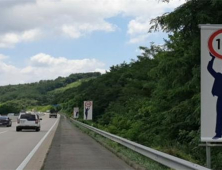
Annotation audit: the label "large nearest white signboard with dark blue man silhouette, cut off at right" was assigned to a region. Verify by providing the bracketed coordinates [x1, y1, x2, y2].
[200, 25, 222, 142]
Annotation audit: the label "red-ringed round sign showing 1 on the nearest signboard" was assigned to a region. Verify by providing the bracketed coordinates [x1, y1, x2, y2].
[208, 29, 222, 59]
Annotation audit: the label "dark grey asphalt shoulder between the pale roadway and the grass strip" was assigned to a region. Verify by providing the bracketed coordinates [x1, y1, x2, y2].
[43, 116, 133, 170]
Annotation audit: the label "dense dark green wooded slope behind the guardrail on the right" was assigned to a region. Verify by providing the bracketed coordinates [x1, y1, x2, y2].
[56, 0, 222, 169]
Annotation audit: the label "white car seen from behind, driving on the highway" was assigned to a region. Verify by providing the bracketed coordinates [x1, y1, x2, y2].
[16, 113, 42, 132]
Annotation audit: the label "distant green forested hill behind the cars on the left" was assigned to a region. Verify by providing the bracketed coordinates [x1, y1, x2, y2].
[0, 72, 101, 114]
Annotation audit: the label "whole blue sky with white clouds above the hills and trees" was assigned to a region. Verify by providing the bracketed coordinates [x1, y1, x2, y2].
[0, 0, 185, 86]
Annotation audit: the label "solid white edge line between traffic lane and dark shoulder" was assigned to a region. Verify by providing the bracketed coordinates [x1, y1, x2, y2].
[16, 115, 60, 170]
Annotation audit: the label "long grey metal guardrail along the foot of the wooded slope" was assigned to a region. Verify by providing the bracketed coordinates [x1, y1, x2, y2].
[71, 118, 210, 170]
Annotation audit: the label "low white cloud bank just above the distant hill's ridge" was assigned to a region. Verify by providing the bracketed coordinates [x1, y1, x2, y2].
[0, 53, 105, 85]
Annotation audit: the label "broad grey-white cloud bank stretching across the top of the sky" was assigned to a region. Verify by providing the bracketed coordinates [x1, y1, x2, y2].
[0, 0, 185, 48]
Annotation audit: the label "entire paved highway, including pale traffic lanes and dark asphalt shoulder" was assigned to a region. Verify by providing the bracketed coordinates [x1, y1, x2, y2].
[0, 114, 133, 170]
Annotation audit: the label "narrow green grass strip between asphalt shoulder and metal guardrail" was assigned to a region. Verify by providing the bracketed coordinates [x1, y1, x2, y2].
[68, 118, 170, 170]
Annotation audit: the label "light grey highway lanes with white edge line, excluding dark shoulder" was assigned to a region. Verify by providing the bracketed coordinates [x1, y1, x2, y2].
[0, 114, 59, 170]
